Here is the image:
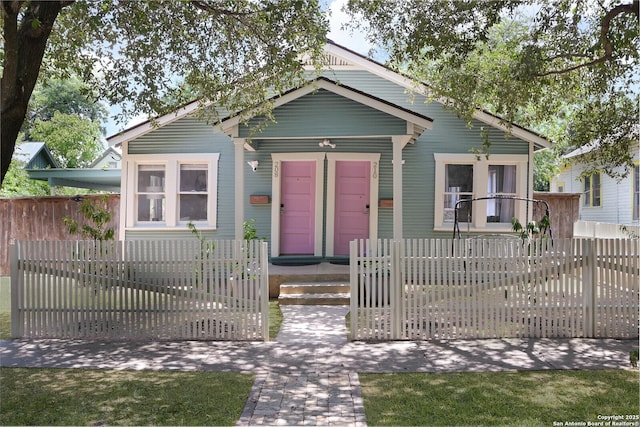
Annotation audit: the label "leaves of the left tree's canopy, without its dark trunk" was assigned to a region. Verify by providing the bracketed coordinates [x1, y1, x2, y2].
[50, 0, 327, 126]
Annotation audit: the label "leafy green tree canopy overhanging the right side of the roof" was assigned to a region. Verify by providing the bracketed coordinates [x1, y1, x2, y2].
[347, 0, 640, 175]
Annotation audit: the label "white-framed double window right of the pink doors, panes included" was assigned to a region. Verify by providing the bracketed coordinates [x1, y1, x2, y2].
[434, 153, 527, 231]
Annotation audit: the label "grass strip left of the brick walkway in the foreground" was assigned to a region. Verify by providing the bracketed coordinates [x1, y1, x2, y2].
[0, 368, 254, 425]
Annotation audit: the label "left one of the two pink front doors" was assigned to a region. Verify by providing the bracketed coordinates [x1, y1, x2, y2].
[280, 161, 316, 255]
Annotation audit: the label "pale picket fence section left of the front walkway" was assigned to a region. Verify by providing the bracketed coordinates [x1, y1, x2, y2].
[11, 240, 269, 340]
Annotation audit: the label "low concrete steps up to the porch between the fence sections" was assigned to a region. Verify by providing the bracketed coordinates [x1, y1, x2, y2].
[278, 281, 351, 305]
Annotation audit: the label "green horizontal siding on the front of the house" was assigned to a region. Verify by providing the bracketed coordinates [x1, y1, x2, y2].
[127, 71, 540, 246]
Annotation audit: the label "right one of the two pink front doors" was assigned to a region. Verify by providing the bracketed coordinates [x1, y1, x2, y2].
[334, 161, 371, 255]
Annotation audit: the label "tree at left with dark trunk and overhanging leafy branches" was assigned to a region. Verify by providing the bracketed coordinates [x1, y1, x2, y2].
[0, 0, 327, 183]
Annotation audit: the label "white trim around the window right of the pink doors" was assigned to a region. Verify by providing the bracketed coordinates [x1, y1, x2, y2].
[433, 153, 528, 232]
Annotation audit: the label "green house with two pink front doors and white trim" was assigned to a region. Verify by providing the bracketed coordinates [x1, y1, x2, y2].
[108, 42, 550, 261]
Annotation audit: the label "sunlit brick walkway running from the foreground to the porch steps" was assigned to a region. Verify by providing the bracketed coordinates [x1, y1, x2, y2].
[237, 306, 366, 426]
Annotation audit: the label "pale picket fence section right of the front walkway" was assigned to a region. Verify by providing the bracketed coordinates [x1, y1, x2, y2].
[350, 238, 640, 340]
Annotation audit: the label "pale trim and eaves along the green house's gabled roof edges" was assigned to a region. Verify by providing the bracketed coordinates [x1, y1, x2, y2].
[107, 40, 551, 148]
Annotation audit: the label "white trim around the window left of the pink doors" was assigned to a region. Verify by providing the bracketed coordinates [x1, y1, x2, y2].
[123, 153, 220, 230]
